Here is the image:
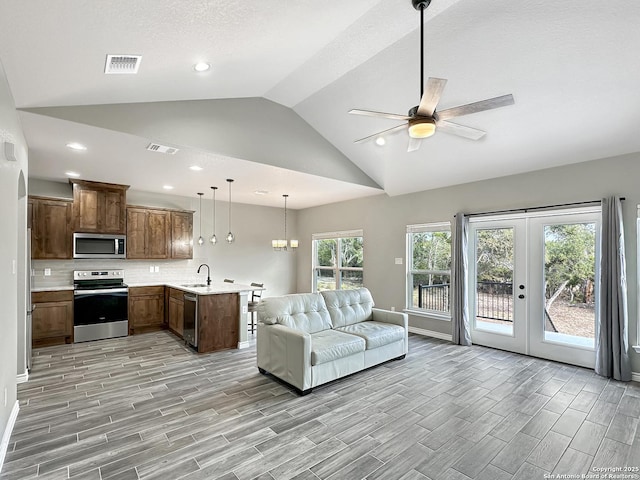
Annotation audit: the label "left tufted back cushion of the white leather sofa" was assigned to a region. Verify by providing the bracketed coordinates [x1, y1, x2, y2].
[258, 293, 331, 333]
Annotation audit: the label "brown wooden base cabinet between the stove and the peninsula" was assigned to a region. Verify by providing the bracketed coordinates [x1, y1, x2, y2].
[129, 285, 165, 335]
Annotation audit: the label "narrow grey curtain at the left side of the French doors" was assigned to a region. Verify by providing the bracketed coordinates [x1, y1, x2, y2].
[451, 213, 471, 345]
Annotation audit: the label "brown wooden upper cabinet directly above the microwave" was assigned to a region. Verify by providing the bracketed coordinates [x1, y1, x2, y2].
[69, 180, 129, 235]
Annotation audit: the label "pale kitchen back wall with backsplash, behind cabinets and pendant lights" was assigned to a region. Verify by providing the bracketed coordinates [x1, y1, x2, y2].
[29, 179, 297, 297]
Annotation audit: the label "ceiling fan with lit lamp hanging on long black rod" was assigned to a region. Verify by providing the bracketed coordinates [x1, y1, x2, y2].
[349, 0, 514, 152]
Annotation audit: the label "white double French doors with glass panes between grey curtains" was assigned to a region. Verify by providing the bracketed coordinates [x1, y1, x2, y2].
[468, 209, 600, 367]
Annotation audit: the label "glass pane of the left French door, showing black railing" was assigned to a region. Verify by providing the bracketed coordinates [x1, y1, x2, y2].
[476, 227, 514, 335]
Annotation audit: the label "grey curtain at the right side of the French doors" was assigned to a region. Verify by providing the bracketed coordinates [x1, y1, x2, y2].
[596, 197, 631, 381]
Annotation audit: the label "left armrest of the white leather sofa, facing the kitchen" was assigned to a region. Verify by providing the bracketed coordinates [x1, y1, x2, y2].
[256, 323, 312, 391]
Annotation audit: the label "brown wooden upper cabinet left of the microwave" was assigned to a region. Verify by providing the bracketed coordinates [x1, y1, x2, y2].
[27, 196, 72, 260]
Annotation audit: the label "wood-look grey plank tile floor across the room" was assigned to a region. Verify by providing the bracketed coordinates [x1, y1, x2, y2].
[0, 332, 640, 480]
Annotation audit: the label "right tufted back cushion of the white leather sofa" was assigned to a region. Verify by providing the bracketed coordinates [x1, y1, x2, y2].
[321, 288, 373, 328]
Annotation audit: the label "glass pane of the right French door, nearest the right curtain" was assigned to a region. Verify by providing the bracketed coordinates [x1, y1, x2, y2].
[543, 223, 596, 348]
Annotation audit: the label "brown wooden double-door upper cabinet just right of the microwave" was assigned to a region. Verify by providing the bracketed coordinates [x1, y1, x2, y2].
[127, 206, 171, 259]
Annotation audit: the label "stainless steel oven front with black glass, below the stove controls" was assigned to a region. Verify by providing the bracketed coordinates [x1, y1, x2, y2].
[73, 288, 129, 342]
